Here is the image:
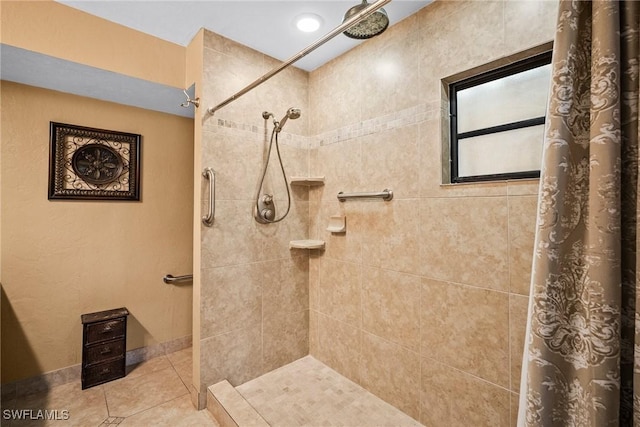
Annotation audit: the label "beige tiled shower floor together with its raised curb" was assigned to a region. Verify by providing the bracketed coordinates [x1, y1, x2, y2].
[207, 356, 422, 427]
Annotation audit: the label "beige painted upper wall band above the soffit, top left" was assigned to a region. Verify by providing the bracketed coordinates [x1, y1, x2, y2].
[0, 0, 185, 88]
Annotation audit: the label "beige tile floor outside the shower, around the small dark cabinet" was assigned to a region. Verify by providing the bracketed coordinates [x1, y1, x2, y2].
[0, 349, 218, 427]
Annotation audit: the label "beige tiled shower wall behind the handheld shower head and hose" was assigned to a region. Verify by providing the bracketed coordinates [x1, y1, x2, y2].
[199, 32, 309, 400]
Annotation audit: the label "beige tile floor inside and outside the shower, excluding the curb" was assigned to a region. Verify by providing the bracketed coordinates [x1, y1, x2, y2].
[5, 349, 421, 427]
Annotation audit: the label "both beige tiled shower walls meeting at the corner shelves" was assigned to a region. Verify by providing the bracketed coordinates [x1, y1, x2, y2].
[200, 0, 557, 427]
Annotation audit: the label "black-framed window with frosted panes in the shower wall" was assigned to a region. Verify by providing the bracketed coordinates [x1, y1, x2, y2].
[449, 52, 551, 183]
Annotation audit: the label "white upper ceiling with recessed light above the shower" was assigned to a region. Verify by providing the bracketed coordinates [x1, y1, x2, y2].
[56, 0, 431, 71]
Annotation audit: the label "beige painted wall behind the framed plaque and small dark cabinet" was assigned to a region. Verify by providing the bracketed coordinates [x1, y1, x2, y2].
[0, 82, 193, 382]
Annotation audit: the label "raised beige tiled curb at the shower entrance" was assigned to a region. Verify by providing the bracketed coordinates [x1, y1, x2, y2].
[207, 380, 269, 427]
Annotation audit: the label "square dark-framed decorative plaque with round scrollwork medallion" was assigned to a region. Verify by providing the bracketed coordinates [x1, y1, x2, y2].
[49, 122, 141, 200]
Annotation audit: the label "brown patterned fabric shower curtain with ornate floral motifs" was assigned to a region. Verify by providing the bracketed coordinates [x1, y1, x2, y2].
[518, 0, 640, 427]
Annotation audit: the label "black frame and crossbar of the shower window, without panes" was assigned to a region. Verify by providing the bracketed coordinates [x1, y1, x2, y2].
[449, 50, 552, 184]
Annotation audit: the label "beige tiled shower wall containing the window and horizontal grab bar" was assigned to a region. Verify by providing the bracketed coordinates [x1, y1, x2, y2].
[309, 1, 557, 426]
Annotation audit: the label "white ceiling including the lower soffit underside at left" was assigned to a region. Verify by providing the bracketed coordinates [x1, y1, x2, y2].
[0, 0, 432, 117]
